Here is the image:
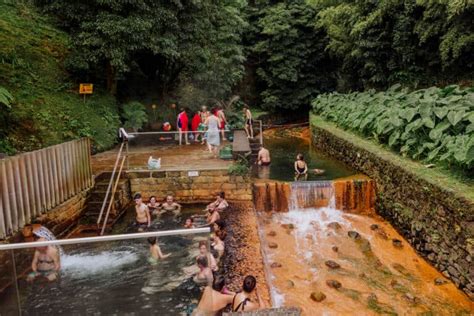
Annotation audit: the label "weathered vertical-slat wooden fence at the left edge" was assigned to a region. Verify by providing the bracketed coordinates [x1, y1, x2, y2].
[0, 138, 93, 238]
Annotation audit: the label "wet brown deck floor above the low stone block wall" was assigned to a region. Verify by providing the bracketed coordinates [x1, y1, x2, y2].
[92, 142, 232, 175]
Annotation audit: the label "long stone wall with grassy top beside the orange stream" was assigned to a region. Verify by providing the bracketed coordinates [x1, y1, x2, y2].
[311, 118, 474, 299]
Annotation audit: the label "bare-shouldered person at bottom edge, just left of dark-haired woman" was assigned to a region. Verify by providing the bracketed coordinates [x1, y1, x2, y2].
[192, 275, 235, 316]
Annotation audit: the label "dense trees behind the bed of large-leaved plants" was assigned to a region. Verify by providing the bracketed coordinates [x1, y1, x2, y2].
[245, 0, 474, 110]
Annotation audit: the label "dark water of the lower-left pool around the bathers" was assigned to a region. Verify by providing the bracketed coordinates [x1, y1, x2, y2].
[0, 207, 209, 315]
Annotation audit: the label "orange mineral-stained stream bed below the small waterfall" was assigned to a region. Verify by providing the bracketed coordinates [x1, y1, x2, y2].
[259, 207, 474, 315]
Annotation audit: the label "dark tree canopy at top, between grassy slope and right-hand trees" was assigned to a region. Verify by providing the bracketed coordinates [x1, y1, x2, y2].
[38, 0, 246, 100]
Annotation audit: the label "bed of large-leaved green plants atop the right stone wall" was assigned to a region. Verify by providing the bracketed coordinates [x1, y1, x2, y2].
[312, 85, 474, 170]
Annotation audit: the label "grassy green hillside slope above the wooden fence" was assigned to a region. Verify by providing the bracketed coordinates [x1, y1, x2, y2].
[0, 1, 119, 154]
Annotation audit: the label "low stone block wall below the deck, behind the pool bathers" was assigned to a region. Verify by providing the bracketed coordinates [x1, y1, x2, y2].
[128, 170, 252, 203]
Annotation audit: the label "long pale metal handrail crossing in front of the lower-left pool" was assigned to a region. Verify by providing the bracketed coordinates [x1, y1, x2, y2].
[0, 227, 211, 251]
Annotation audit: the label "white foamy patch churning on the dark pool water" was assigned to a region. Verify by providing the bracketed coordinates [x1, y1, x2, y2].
[61, 251, 138, 277]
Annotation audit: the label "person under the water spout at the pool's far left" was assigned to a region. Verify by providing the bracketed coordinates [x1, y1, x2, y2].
[27, 237, 61, 282]
